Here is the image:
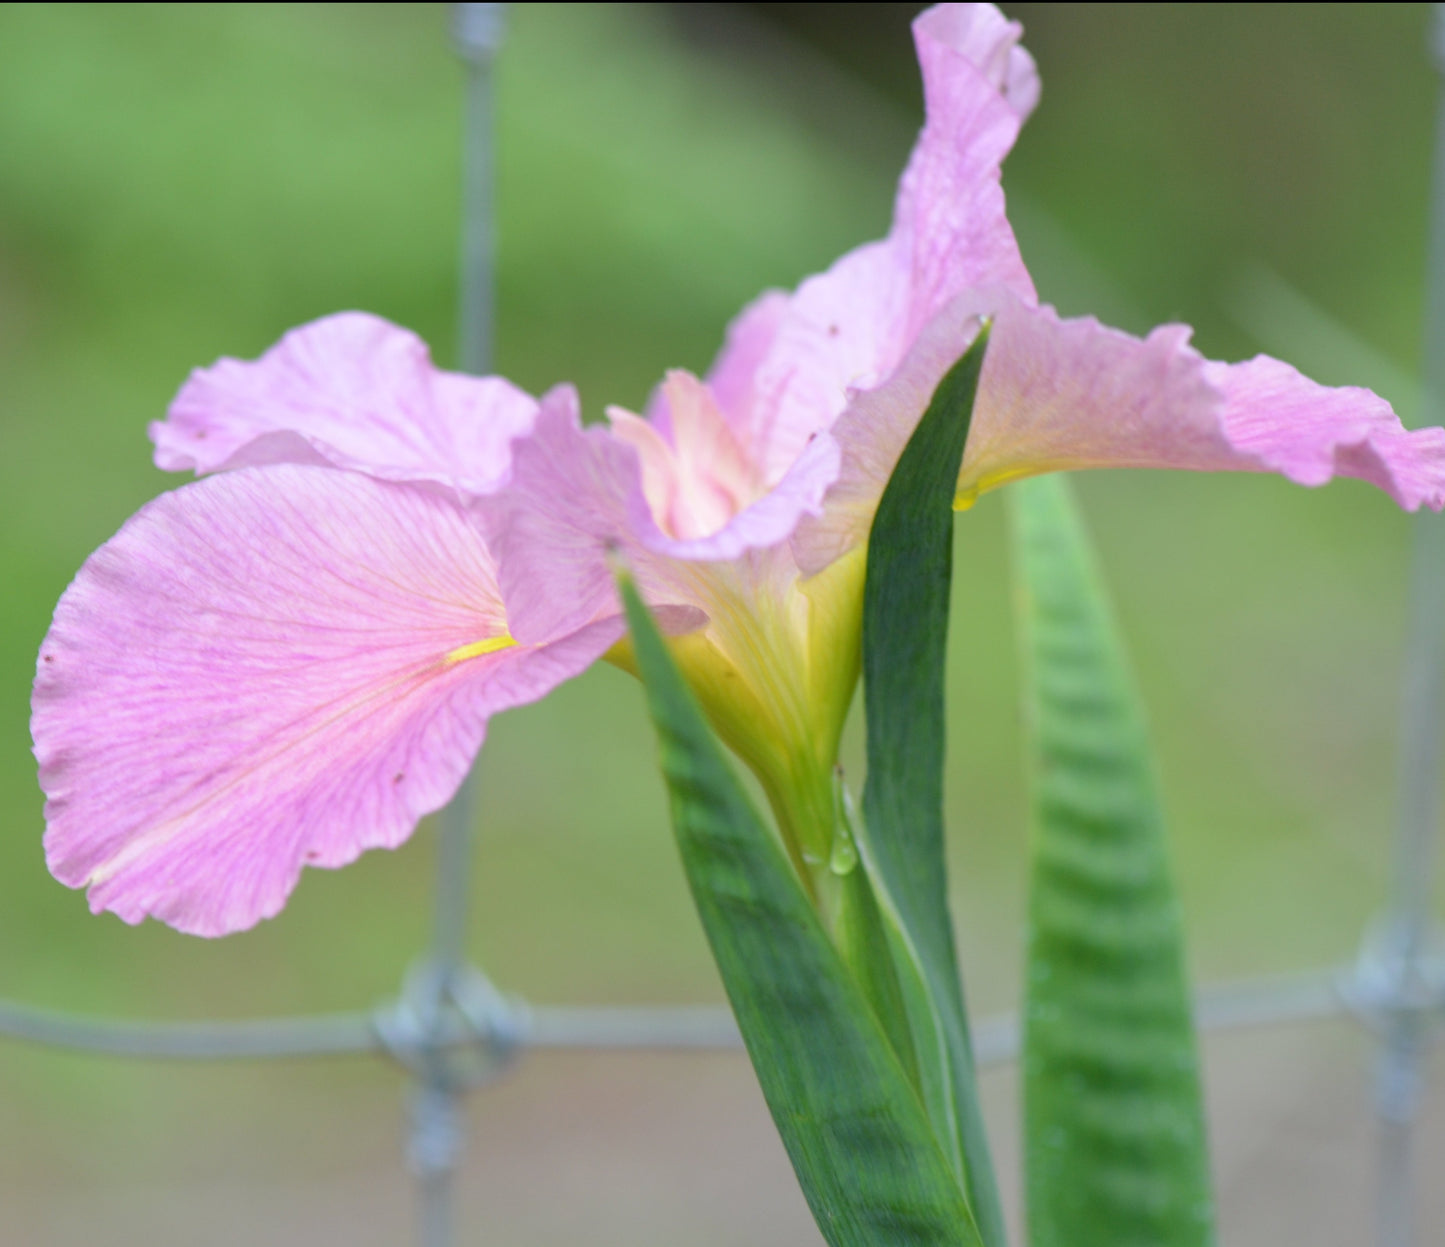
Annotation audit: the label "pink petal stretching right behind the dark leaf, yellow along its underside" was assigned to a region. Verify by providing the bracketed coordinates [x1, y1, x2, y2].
[792, 283, 1445, 575]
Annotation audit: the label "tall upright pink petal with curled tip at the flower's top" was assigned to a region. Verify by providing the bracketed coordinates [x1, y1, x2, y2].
[699, 4, 1039, 484]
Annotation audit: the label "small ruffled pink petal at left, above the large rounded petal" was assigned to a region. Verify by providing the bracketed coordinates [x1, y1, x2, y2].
[150, 312, 536, 494]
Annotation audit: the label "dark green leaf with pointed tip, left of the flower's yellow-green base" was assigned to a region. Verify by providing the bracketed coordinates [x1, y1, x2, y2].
[621, 578, 980, 1247]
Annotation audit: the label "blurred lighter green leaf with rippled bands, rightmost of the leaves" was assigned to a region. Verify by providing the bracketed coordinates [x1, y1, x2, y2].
[1012, 477, 1214, 1247]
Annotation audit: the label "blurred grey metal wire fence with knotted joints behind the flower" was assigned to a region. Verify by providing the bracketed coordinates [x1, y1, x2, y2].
[0, 3, 1445, 1247]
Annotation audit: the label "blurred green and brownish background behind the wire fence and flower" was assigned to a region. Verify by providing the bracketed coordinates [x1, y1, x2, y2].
[0, 4, 1445, 1244]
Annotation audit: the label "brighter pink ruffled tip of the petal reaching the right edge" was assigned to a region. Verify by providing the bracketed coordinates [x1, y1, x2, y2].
[1205, 355, 1445, 512]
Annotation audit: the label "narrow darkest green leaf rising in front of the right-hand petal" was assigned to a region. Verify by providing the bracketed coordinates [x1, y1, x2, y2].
[858, 328, 1004, 1247]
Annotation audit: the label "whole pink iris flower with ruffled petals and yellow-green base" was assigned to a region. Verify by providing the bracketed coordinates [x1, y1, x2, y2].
[33, 4, 1445, 935]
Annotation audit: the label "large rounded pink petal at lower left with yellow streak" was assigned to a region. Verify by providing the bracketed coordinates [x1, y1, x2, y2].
[32, 465, 621, 935]
